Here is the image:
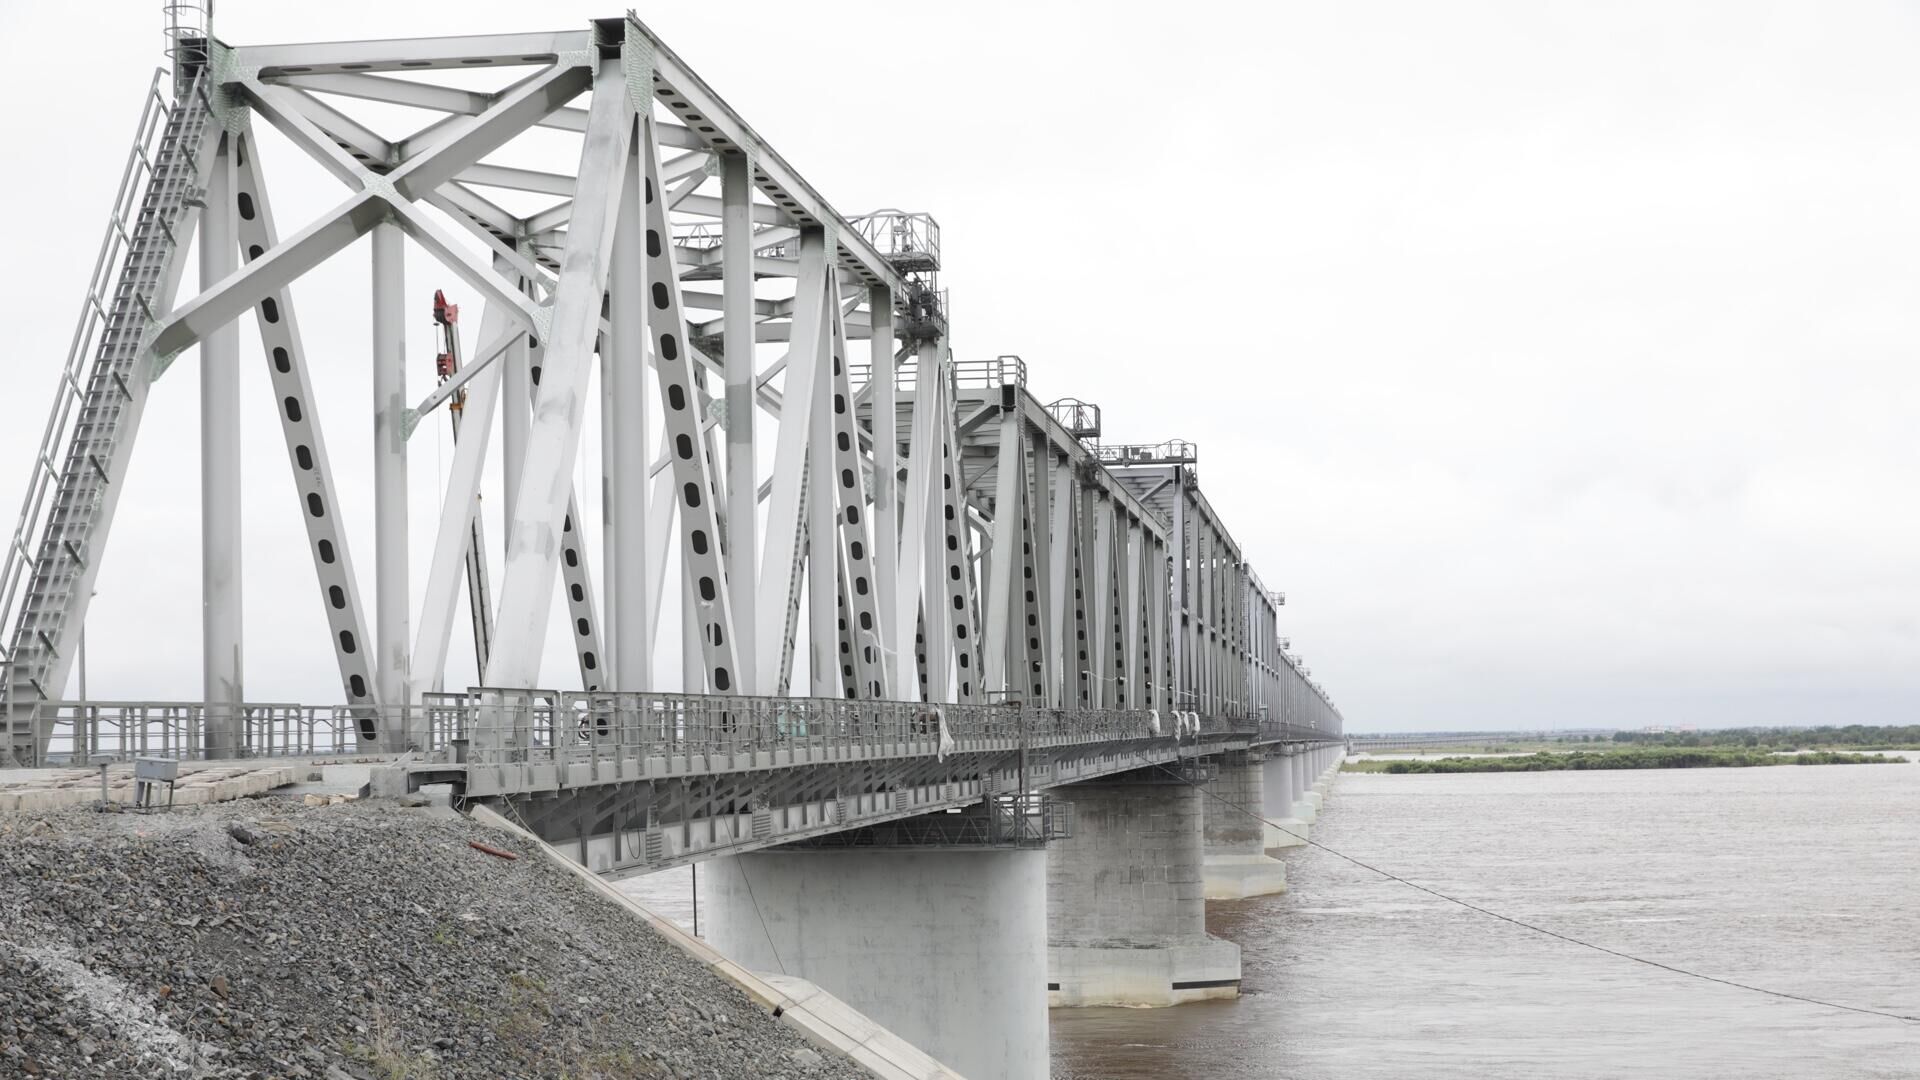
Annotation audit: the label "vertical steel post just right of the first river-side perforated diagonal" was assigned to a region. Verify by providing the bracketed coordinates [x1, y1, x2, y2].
[720, 152, 756, 694]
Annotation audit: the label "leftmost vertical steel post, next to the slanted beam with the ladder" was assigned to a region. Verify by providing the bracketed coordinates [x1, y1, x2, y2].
[200, 136, 244, 757]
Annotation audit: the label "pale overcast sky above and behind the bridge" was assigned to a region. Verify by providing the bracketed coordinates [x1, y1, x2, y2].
[0, 0, 1920, 730]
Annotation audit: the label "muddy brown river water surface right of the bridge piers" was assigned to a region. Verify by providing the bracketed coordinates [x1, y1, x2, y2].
[1052, 763, 1920, 1080]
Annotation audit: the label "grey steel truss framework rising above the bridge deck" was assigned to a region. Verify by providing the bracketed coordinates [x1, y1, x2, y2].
[0, 15, 1338, 794]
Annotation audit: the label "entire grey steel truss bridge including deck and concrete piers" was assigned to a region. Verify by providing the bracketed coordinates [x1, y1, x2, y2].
[0, 10, 1342, 1078]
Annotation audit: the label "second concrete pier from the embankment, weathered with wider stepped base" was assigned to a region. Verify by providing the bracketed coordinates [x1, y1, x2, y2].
[1046, 769, 1240, 1007]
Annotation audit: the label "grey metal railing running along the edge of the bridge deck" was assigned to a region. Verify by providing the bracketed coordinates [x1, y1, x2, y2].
[18, 688, 1340, 765]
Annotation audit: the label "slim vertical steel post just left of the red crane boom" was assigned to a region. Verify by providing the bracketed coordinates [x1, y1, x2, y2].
[372, 221, 411, 737]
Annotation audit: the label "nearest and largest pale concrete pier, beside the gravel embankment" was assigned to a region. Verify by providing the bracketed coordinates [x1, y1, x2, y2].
[699, 846, 1048, 1080]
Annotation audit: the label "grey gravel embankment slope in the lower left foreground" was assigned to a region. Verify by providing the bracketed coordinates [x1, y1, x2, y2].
[0, 798, 862, 1080]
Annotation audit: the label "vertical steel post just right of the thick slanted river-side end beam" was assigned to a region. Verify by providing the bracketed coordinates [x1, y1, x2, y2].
[601, 138, 656, 692]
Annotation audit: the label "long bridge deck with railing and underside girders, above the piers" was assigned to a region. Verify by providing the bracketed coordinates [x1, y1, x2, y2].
[18, 688, 1340, 876]
